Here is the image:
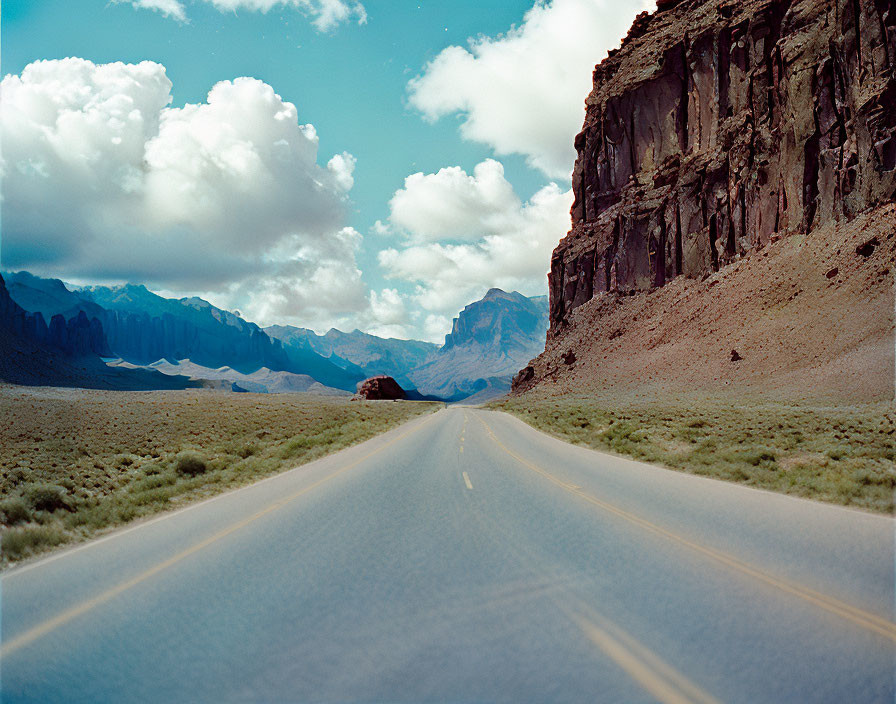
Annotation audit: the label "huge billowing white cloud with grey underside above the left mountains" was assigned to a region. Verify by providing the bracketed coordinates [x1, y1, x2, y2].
[0, 58, 368, 325]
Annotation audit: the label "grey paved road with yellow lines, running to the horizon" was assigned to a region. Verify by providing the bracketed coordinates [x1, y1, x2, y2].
[0, 408, 896, 704]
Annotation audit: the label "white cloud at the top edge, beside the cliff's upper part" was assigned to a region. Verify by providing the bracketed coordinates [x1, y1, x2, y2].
[408, 0, 655, 178]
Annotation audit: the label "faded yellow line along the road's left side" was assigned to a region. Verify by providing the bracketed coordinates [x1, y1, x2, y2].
[0, 413, 436, 658]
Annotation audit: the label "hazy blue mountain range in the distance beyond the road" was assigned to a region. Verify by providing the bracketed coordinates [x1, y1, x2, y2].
[0, 272, 548, 401]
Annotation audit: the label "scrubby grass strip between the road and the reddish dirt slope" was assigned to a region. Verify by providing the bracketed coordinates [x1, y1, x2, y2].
[487, 396, 896, 514]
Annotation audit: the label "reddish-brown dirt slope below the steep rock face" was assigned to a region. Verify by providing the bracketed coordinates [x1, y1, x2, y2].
[514, 204, 896, 403]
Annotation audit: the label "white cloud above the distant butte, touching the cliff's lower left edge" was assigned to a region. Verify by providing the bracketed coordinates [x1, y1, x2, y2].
[378, 160, 572, 320]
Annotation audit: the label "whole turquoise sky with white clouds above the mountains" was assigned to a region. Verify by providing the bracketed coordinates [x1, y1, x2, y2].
[0, 0, 653, 342]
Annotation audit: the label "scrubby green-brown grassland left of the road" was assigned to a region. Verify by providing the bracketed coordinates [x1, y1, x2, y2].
[0, 387, 441, 566]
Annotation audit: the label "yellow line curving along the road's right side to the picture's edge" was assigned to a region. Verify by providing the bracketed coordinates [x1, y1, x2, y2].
[479, 418, 896, 642]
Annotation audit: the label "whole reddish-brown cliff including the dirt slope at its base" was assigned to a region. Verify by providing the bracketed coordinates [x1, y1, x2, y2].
[512, 0, 896, 403]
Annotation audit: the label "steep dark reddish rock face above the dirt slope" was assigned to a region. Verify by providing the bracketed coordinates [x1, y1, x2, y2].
[549, 0, 896, 336]
